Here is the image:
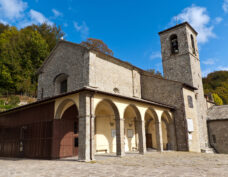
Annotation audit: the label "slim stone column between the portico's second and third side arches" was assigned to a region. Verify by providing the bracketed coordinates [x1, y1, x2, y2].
[137, 120, 146, 154]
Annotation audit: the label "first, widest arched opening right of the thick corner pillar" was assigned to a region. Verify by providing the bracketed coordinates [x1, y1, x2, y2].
[95, 100, 118, 153]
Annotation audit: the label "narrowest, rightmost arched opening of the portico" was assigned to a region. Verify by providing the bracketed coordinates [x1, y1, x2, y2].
[161, 111, 176, 150]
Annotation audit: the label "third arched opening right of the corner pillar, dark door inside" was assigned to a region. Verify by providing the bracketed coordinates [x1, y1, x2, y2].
[144, 107, 160, 149]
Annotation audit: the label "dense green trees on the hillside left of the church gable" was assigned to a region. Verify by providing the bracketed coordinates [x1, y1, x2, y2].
[0, 27, 49, 95]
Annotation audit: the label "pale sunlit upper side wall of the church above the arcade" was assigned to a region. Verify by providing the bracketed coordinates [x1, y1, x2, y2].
[89, 52, 141, 97]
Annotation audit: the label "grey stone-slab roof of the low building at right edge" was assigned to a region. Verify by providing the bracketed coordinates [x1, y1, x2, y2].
[207, 105, 228, 120]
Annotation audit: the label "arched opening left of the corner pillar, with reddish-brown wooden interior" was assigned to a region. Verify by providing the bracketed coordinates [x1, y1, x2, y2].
[52, 100, 79, 158]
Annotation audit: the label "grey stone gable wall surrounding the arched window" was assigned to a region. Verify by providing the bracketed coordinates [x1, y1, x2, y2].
[38, 41, 89, 99]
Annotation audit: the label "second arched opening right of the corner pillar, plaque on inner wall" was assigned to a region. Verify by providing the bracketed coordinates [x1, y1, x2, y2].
[124, 105, 141, 152]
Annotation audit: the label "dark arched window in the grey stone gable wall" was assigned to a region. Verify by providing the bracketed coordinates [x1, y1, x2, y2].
[53, 73, 68, 95]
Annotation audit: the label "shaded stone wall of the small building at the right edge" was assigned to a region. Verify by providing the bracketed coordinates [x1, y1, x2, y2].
[208, 119, 228, 154]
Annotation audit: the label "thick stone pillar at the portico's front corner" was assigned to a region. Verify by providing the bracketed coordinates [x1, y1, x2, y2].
[78, 92, 94, 161]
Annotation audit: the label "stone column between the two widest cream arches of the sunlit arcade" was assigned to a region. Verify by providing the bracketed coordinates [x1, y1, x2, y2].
[116, 117, 125, 157]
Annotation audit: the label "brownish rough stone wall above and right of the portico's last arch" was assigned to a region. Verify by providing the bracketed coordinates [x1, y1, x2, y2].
[141, 74, 188, 151]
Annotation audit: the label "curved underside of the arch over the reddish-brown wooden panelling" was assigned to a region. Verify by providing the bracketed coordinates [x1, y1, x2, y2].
[55, 98, 78, 119]
